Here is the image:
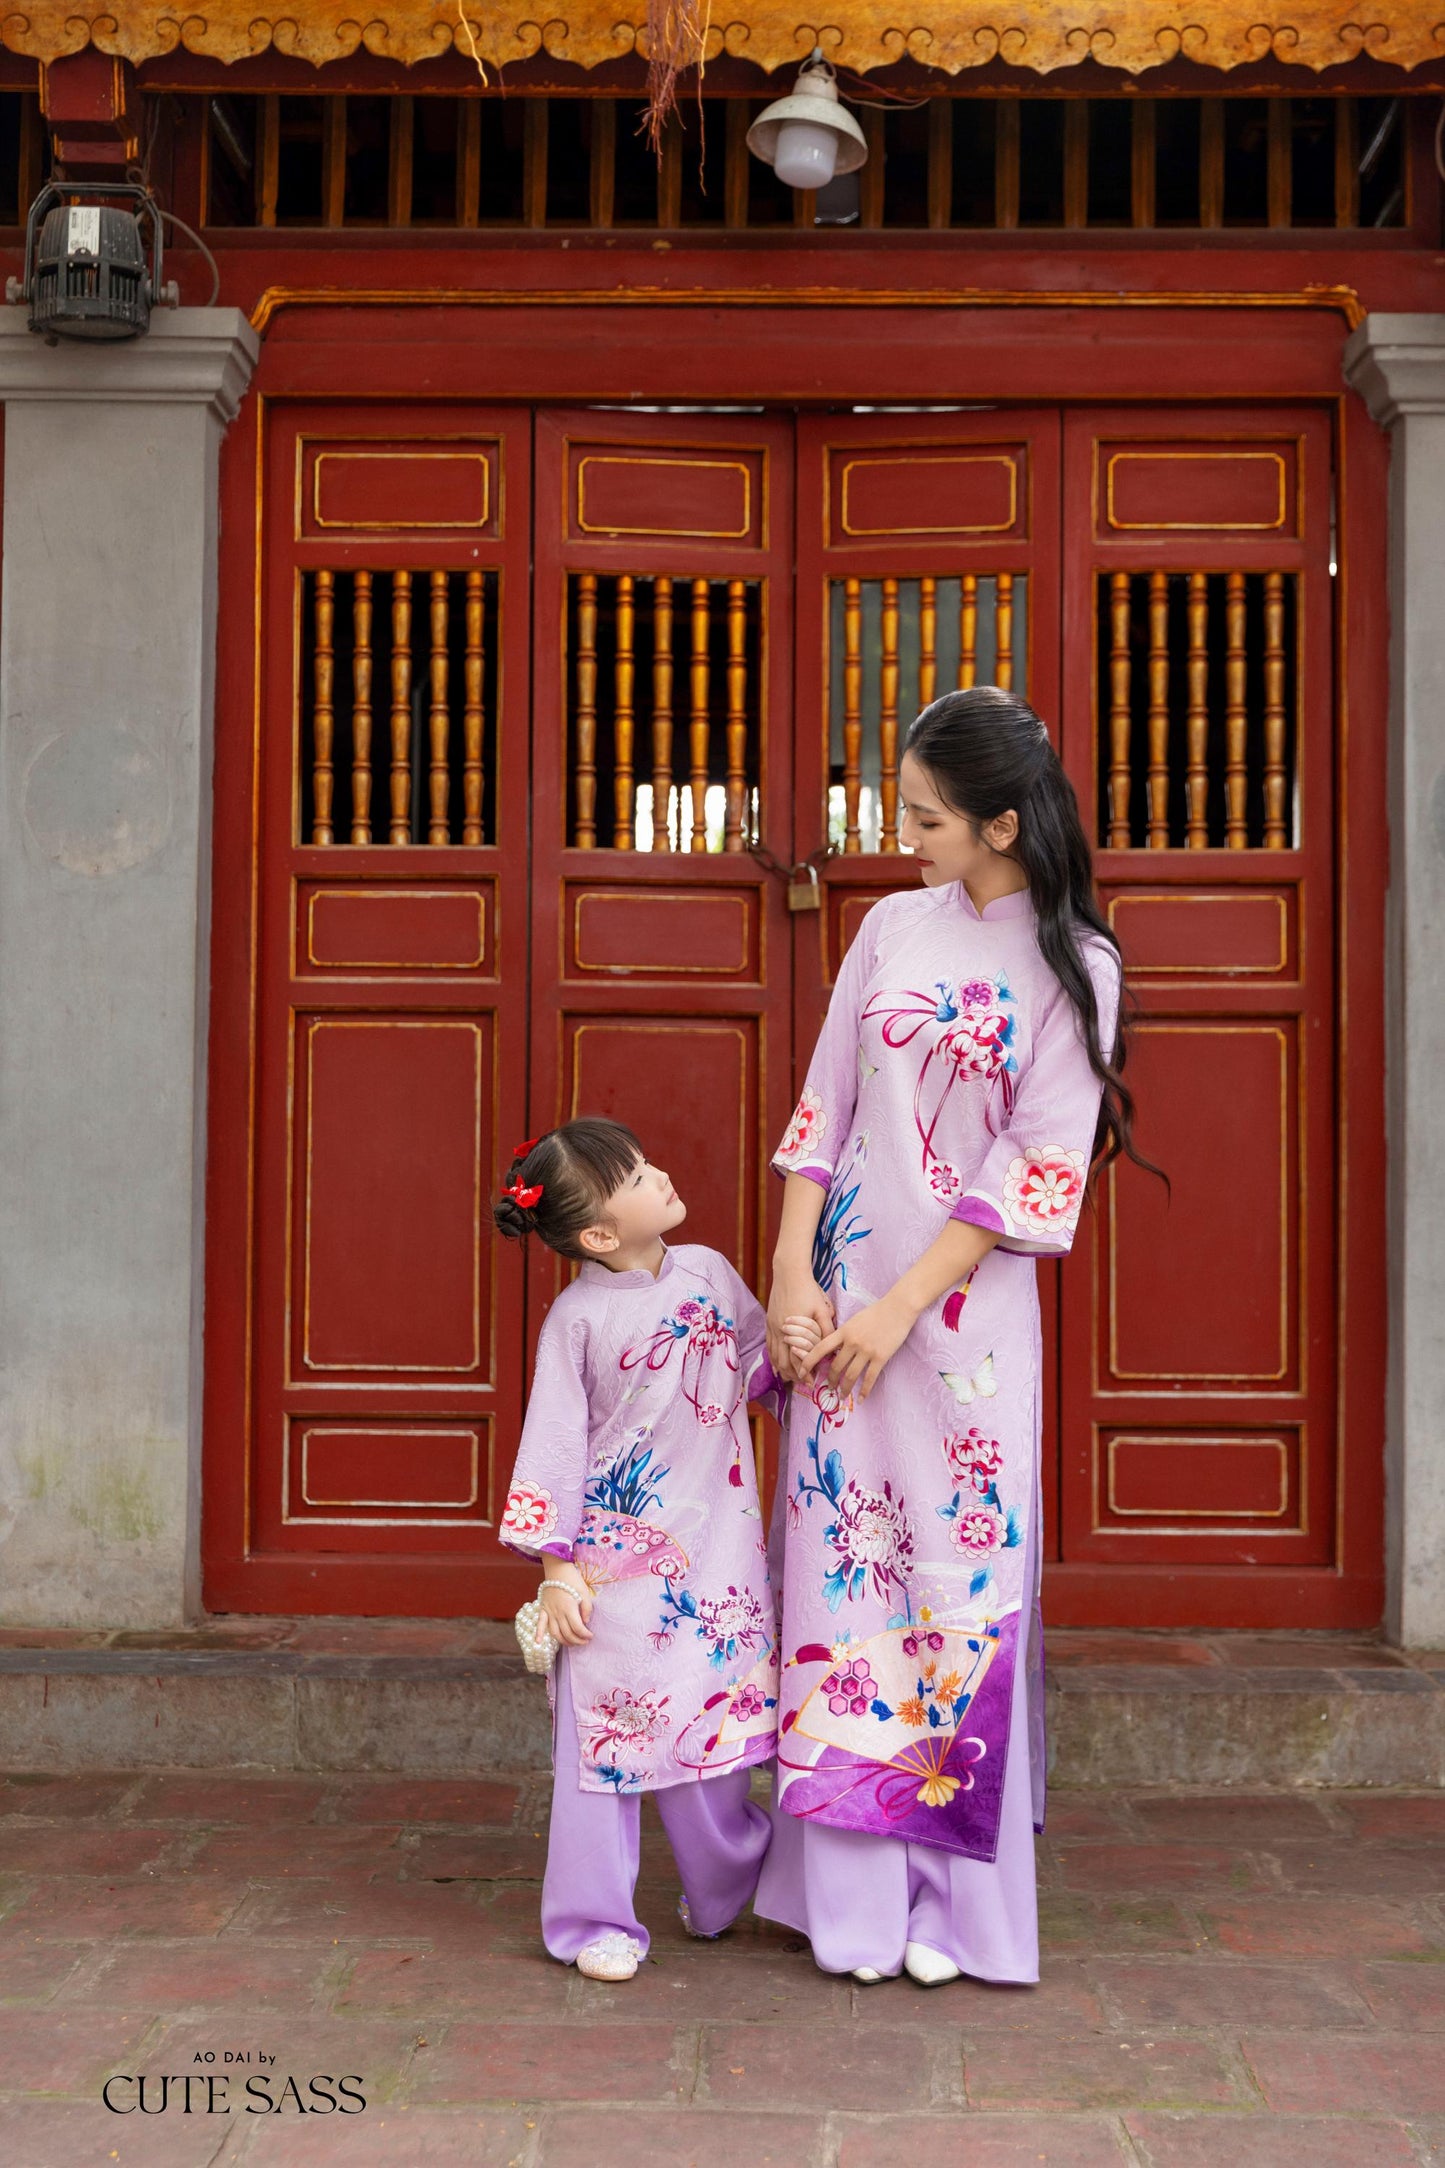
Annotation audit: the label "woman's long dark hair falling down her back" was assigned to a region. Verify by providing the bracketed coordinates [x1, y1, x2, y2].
[903, 685, 1159, 1173]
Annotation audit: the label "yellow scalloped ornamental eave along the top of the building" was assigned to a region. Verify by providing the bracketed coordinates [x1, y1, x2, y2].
[0, 0, 1445, 76]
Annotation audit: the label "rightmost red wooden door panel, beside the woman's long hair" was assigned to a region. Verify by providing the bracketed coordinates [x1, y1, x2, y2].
[1053, 408, 1354, 1626]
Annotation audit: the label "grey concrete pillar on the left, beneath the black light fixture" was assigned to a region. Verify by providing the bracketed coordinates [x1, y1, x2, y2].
[0, 308, 258, 1626]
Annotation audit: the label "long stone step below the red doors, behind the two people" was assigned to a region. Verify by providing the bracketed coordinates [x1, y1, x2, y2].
[0, 1619, 1445, 1791]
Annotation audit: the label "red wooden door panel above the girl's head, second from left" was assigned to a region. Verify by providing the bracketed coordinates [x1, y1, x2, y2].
[531, 410, 793, 1396]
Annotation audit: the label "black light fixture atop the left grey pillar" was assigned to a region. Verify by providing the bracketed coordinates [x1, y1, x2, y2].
[4, 180, 180, 347]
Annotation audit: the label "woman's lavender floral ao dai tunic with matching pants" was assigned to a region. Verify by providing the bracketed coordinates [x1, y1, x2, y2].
[756, 882, 1118, 1982]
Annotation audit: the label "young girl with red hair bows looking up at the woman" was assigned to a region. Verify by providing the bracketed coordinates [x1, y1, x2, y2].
[494, 1121, 817, 1979]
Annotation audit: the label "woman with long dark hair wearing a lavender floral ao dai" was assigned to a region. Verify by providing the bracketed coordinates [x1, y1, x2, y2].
[756, 687, 1133, 1986]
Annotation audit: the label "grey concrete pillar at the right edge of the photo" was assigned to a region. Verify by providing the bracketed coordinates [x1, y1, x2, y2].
[1345, 314, 1445, 1648]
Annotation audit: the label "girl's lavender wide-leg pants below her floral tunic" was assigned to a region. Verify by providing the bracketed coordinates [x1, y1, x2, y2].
[542, 1656, 771, 1964]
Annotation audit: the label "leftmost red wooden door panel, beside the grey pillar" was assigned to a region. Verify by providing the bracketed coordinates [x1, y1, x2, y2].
[206, 403, 531, 1613]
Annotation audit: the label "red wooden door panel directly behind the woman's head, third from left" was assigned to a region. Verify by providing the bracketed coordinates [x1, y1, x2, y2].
[793, 408, 1062, 1557]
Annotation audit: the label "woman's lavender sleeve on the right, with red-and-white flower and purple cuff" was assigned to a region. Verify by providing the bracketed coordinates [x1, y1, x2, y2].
[951, 941, 1120, 1257]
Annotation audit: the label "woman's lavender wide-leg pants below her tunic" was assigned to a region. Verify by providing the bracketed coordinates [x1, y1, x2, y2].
[754, 1586, 1038, 1986]
